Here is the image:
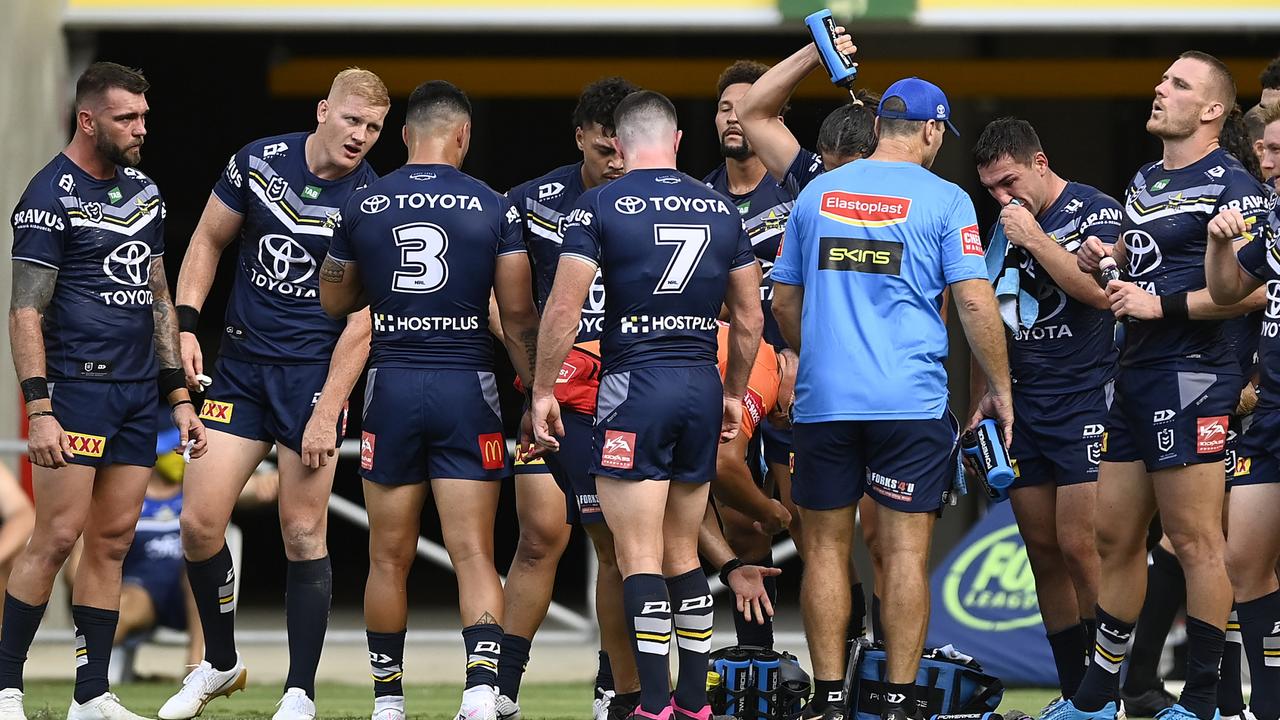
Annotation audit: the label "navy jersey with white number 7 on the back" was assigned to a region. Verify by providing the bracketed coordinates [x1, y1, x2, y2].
[561, 169, 755, 373]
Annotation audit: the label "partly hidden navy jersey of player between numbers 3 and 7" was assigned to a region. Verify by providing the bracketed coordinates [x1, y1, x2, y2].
[507, 163, 604, 342]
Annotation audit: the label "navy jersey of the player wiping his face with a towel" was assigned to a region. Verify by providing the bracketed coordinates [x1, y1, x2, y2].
[1009, 182, 1121, 395]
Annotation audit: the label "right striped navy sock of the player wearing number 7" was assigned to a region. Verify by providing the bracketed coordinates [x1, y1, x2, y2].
[667, 568, 716, 712]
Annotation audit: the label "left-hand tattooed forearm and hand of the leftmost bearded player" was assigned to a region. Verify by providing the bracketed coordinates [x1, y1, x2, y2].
[9, 260, 72, 468]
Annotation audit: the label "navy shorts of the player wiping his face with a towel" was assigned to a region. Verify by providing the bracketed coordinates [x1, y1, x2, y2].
[1009, 383, 1112, 489]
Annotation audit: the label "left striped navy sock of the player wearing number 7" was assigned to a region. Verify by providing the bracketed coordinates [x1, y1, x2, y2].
[622, 573, 675, 715]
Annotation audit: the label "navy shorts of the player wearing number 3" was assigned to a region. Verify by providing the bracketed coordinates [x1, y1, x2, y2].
[360, 368, 511, 486]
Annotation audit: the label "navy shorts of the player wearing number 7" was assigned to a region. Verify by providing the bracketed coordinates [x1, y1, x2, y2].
[590, 365, 724, 483]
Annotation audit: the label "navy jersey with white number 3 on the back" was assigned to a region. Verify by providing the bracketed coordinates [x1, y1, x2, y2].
[329, 165, 525, 372]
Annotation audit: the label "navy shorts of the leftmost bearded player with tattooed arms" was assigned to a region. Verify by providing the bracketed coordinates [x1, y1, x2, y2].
[49, 380, 160, 468]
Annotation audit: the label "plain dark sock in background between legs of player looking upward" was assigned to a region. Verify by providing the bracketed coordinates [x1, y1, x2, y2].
[1124, 546, 1187, 696]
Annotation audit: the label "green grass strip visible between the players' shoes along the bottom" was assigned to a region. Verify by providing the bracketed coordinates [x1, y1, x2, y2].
[17, 682, 1057, 720]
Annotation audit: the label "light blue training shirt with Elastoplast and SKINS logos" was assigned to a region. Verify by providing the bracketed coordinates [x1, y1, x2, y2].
[773, 155, 987, 415]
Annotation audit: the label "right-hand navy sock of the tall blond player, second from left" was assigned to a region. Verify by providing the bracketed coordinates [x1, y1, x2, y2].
[284, 555, 333, 700]
